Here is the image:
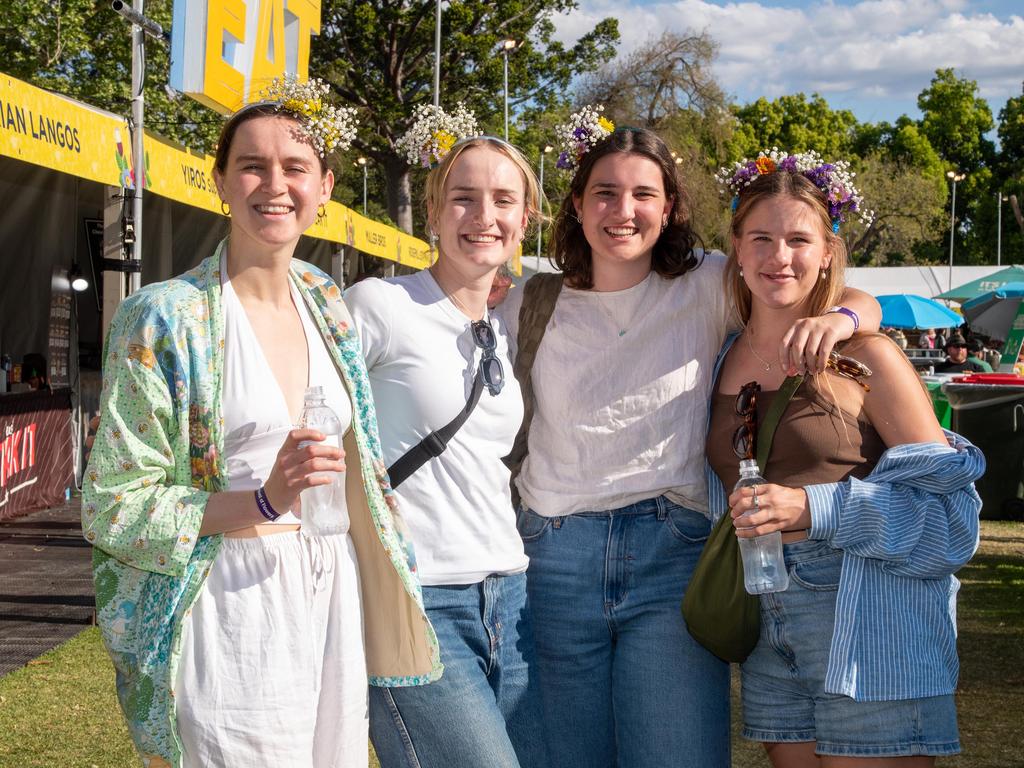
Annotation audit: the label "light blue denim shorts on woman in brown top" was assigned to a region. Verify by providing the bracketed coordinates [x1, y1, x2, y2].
[742, 540, 959, 758]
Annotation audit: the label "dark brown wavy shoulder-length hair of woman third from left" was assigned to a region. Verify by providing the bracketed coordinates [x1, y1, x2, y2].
[551, 128, 703, 290]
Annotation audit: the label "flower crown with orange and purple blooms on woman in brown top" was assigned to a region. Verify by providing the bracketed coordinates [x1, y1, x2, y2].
[715, 146, 874, 232]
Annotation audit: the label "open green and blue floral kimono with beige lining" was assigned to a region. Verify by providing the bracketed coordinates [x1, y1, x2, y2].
[82, 241, 441, 768]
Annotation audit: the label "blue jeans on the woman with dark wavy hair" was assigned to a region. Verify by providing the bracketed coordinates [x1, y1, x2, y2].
[517, 497, 730, 768]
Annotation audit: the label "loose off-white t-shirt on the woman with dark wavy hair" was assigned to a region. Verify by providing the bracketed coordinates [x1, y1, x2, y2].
[500, 251, 735, 516]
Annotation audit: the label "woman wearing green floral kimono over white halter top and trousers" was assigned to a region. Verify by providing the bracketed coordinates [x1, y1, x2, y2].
[83, 102, 439, 768]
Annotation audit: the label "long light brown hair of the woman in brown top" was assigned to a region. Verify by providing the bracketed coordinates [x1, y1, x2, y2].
[724, 171, 847, 326]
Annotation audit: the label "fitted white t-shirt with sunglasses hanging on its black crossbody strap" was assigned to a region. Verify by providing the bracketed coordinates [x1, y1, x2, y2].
[345, 269, 527, 586]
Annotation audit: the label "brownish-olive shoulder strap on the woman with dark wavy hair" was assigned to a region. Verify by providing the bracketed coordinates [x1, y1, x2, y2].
[504, 273, 562, 495]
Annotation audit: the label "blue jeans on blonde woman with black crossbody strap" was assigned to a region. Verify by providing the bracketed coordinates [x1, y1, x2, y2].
[370, 573, 552, 768]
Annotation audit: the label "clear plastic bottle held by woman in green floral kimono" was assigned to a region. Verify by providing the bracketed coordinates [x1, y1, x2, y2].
[299, 387, 348, 536]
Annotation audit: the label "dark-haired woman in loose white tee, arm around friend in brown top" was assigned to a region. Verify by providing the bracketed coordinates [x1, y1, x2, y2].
[502, 123, 881, 768]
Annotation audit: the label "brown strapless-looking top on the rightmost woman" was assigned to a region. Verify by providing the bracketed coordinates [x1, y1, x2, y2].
[708, 374, 886, 494]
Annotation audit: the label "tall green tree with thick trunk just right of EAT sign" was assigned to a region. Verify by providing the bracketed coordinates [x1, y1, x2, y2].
[310, 0, 618, 231]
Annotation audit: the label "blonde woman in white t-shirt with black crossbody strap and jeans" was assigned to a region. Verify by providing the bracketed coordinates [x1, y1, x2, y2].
[345, 137, 551, 768]
